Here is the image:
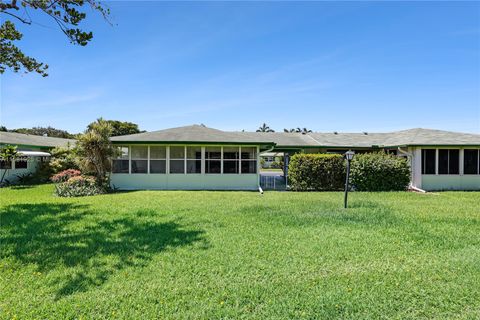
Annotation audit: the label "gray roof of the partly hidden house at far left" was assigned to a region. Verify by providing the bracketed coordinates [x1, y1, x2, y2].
[0, 131, 75, 147]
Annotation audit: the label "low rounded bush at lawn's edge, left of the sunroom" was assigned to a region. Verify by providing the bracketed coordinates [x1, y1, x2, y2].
[55, 175, 105, 197]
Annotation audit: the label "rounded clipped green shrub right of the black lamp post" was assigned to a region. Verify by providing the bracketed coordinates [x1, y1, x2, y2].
[350, 152, 410, 191]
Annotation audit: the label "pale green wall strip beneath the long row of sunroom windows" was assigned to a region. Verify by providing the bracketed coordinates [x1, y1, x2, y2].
[111, 173, 258, 190]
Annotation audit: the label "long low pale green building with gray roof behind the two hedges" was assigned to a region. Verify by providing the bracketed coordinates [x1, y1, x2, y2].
[111, 125, 480, 190]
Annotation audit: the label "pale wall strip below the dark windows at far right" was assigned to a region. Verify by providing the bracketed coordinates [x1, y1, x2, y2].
[422, 175, 480, 191]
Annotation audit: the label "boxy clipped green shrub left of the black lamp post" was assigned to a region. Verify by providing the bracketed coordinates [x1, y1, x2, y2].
[288, 153, 345, 191]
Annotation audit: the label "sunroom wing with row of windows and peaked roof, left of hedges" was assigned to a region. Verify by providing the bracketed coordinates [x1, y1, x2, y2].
[111, 125, 275, 190]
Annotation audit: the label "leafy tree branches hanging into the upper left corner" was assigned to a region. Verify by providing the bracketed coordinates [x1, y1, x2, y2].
[0, 0, 110, 77]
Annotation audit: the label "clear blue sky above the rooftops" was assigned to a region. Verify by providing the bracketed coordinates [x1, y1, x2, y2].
[0, 1, 480, 133]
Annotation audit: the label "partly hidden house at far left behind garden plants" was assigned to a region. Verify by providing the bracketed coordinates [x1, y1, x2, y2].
[0, 131, 75, 182]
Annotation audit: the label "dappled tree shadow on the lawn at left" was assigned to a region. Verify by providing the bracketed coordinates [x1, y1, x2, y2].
[0, 203, 205, 299]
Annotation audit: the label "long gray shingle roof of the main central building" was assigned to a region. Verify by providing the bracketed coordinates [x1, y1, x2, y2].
[111, 125, 480, 148]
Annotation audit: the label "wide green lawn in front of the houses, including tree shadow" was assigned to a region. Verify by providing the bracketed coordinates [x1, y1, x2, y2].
[0, 185, 480, 319]
